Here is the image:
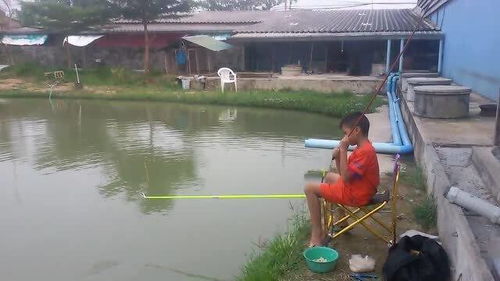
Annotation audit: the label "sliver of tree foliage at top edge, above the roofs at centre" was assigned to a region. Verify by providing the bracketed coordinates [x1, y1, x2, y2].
[198, 0, 288, 11]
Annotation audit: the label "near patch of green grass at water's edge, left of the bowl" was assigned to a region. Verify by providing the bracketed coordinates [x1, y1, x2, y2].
[237, 213, 310, 281]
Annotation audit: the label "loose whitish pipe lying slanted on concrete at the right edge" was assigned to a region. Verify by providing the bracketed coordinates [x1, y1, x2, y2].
[445, 186, 500, 224]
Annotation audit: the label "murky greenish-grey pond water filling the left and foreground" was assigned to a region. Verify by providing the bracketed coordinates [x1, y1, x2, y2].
[0, 99, 339, 281]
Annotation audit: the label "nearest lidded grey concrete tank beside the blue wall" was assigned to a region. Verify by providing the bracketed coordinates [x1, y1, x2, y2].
[414, 86, 471, 118]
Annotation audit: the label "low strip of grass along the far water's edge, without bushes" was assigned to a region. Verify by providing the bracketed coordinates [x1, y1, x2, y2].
[0, 88, 382, 117]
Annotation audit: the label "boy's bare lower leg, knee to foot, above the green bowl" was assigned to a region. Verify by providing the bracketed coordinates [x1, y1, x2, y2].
[304, 183, 324, 246]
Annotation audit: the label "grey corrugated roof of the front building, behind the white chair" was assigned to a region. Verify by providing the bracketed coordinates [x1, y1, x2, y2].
[235, 9, 438, 33]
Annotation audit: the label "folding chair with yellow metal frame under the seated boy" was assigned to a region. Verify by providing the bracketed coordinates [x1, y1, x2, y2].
[321, 155, 400, 245]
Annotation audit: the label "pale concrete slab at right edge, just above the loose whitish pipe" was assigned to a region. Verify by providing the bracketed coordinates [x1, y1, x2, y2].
[472, 147, 500, 202]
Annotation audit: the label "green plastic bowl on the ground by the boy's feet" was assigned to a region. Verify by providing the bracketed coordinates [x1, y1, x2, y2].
[304, 247, 339, 273]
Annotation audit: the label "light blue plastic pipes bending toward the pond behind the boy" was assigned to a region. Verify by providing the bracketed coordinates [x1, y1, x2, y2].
[305, 73, 413, 154]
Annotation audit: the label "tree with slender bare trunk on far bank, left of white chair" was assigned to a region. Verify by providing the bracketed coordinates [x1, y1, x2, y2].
[114, 0, 191, 73]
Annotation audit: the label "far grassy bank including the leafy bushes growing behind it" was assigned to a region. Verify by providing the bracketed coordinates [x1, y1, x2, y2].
[0, 65, 383, 117]
